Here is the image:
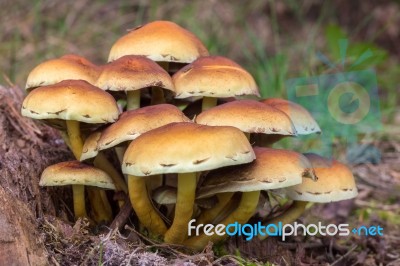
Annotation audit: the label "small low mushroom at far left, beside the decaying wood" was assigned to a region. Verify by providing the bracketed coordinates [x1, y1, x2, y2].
[39, 161, 115, 219]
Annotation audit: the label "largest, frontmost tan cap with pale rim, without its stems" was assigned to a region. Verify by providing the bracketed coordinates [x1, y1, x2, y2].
[122, 123, 255, 176]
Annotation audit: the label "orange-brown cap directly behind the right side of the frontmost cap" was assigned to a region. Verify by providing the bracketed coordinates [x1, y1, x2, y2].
[196, 100, 296, 135]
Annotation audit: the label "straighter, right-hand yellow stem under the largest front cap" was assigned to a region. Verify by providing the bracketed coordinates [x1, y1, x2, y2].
[164, 173, 196, 244]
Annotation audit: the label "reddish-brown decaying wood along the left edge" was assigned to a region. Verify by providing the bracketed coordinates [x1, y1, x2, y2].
[0, 86, 70, 265]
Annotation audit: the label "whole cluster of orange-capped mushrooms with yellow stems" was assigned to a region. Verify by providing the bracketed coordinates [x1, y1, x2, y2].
[21, 21, 357, 250]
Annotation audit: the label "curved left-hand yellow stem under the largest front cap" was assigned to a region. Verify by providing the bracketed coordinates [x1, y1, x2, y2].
[128, 175, 167, 235]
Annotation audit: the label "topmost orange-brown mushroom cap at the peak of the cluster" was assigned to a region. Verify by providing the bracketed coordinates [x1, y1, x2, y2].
[108, 21, 208, 63]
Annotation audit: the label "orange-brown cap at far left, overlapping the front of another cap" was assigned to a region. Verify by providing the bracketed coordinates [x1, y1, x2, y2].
[21, 80, 119, 124]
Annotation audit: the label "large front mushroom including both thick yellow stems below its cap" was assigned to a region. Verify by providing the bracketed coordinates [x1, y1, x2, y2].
[122, 123, 255, 243]
